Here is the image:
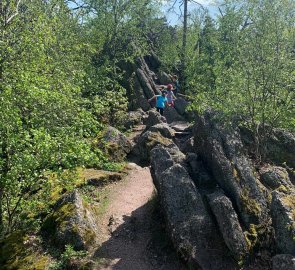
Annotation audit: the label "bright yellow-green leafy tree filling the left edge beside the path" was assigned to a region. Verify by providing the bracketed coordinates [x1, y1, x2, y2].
[0, 1, 97, 233]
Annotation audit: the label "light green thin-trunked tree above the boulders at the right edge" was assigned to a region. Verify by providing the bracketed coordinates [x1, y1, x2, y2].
[194, 0, 294, 147]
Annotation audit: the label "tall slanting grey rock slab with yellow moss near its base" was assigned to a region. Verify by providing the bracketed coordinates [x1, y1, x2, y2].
[194, 112, 269, 228]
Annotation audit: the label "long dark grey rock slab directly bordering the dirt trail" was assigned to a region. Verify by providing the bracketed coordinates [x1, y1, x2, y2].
[151, 147, 237, 270]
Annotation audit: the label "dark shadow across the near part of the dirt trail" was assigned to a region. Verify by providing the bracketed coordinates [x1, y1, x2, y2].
[93, 197, 186, 270]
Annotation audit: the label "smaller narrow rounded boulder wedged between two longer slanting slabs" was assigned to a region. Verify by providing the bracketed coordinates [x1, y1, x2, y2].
[207, 191, 249, 261]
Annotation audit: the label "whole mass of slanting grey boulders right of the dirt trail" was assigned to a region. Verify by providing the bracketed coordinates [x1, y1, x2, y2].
[123, 53, 295, 270]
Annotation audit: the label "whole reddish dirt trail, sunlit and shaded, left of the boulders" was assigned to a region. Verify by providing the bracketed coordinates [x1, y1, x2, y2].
[94, 164, 184, 270]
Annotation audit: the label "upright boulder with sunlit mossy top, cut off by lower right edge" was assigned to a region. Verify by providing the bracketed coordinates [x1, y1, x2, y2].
[271, 190, 295, 255]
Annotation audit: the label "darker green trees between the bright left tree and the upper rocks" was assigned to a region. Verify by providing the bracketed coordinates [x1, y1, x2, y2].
[83, 0, 163, 128]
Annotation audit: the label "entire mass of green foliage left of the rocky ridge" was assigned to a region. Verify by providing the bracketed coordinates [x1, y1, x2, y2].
[0, 0, 166, 235]
